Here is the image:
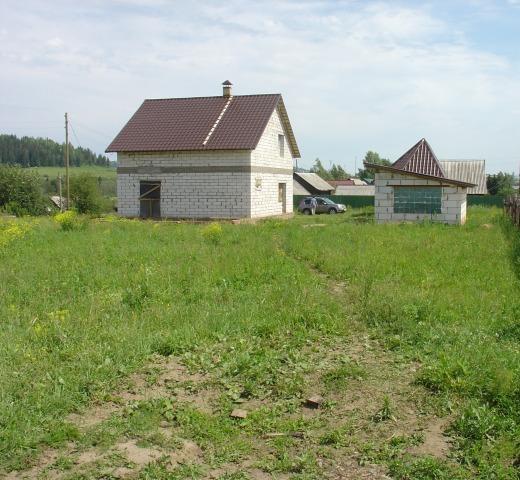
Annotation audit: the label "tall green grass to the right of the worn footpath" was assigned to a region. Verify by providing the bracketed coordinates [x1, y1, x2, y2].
[285, 207, 520, 478]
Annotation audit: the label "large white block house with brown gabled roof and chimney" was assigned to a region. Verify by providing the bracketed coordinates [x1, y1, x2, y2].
[107, 81, 300, 219]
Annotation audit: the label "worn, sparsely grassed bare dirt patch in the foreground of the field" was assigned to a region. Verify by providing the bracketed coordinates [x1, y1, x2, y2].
[6, 258, 450, 480]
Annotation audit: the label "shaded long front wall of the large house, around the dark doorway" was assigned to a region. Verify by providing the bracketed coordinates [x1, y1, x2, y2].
[117, 150, 251, 218]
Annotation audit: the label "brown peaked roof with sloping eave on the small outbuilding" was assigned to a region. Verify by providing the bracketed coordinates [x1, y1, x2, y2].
[364, 138, 476, 188]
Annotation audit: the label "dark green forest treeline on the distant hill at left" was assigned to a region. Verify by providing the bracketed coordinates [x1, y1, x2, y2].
[0, 135, 110, 167]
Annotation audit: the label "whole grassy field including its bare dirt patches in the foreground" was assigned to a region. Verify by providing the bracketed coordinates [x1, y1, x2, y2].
[0, 207, 520, 479]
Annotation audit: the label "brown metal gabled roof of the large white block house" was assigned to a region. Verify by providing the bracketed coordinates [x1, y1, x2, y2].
[106, 94, 300, 158]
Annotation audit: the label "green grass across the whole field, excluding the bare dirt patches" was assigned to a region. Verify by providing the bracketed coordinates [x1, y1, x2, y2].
[0, 207, 520, 479]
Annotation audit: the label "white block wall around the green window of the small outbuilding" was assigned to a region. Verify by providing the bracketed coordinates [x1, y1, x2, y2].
[374, 172, 467, 224]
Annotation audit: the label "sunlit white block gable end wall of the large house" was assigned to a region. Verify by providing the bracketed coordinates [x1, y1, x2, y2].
[251, 110, 293, 217]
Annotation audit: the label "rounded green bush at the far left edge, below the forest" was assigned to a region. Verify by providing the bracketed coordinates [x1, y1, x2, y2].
[0, 165, 45, 216]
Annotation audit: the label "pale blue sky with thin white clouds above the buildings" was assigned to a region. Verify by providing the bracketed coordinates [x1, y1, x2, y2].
[0, 0, 520, 173]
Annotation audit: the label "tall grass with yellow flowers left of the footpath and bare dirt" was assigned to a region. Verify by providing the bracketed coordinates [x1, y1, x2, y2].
[0, 220, 343, 467]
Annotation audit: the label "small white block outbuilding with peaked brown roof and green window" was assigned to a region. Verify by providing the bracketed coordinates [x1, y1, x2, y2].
[365, 138, 476, 224]
